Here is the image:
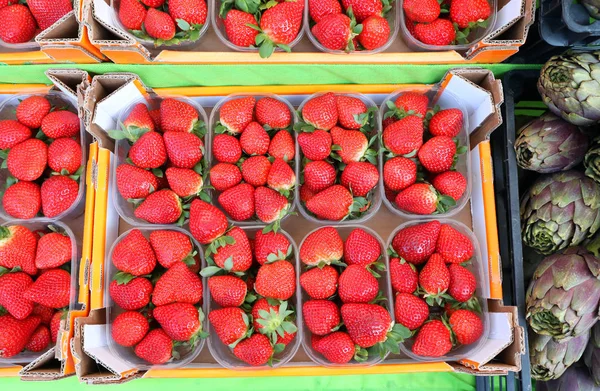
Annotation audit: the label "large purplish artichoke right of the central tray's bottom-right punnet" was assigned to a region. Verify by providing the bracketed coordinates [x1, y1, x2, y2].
[525, 247, 600, 341]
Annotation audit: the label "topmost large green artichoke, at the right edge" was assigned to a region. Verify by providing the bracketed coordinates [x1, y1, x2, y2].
[538, 51, 600, 126]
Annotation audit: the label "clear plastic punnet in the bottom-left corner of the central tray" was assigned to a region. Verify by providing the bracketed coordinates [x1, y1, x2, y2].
[104, 225, 208, 370]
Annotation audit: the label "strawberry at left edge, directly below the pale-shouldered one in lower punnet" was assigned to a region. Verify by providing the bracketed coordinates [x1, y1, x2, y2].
[0, 272, 33, 319]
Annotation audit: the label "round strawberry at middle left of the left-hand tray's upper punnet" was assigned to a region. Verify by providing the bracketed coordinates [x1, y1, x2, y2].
[6, 138, 48, 181]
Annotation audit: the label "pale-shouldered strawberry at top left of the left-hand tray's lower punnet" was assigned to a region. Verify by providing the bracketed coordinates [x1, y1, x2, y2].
[0, 225, 38, 276]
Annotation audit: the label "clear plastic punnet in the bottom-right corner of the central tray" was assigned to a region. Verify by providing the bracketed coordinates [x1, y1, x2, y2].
[386, 219, 490, 362]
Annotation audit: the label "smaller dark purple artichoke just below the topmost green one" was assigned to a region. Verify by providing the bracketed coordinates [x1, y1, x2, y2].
[515, 113, 588, 174]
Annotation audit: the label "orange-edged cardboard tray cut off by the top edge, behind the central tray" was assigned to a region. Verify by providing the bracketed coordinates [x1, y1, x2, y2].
[84, 0, 535, 64]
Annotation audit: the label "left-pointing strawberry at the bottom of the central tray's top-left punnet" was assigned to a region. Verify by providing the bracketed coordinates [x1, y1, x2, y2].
[135, 187, 183, 224]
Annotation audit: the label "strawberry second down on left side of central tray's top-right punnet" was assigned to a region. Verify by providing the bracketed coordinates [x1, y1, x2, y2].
[383, 115, 423, 156]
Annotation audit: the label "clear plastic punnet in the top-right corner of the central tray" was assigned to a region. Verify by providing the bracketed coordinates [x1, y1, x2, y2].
[379, 85, 472, 220]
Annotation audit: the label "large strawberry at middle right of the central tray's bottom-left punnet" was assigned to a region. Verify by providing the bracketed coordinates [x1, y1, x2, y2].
[152, 262, 202, 308]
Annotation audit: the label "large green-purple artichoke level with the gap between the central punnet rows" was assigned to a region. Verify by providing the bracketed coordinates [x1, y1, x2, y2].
[521, 170, 600, 255]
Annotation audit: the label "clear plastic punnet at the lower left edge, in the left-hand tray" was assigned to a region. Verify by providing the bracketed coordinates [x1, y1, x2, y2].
[0, 219, 81, 365]
